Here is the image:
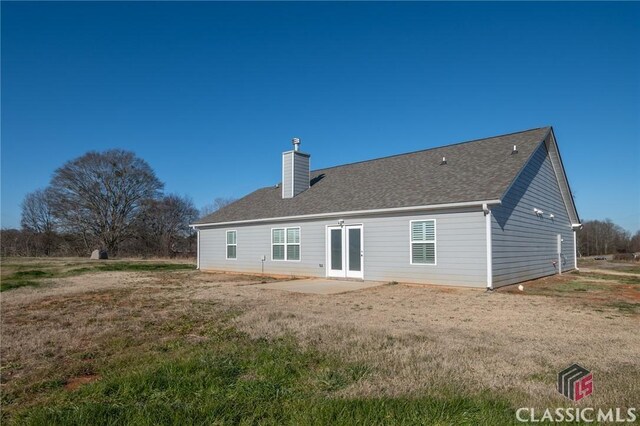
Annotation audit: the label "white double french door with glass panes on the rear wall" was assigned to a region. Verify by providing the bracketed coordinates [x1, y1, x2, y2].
[327, 225, 364, 279]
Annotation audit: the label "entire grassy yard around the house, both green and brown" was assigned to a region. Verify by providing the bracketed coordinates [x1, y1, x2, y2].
[0, 259, 640, 425]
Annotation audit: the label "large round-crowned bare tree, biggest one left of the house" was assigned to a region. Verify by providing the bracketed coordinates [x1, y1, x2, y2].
[51, 149, 164, 255]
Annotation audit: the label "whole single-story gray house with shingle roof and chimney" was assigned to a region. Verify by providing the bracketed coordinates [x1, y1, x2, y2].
[192, 127, 581, 288]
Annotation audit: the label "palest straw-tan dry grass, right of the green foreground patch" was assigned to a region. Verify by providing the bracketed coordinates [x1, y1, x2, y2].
[224, 276, 640, 406]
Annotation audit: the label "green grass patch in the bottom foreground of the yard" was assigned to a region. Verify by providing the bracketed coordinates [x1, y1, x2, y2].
[4, 319, 514, 425]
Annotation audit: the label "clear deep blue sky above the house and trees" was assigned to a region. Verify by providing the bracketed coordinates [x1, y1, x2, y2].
[1, 2, 640, 232]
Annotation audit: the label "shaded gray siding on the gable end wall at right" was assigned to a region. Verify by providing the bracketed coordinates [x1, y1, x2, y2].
[492, 143, 575, 287]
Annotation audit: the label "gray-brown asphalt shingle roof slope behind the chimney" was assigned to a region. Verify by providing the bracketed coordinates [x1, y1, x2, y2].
[196, 127, 551, 224]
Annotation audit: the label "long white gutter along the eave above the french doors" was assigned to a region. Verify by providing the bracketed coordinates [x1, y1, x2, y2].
[189, 200, 502, 229]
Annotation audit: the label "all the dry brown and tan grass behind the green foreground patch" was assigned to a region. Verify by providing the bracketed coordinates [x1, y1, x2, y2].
[0, 260, 640, 416]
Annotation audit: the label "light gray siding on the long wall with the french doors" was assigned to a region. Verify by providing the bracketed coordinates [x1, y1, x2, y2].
[199, 208, 487, 287]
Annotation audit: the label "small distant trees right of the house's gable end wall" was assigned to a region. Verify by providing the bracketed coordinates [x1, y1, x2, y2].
[578, 219, 640, 256]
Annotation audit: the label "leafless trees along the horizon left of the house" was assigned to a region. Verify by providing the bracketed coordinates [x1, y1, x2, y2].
[0, 150, 233, 257]
